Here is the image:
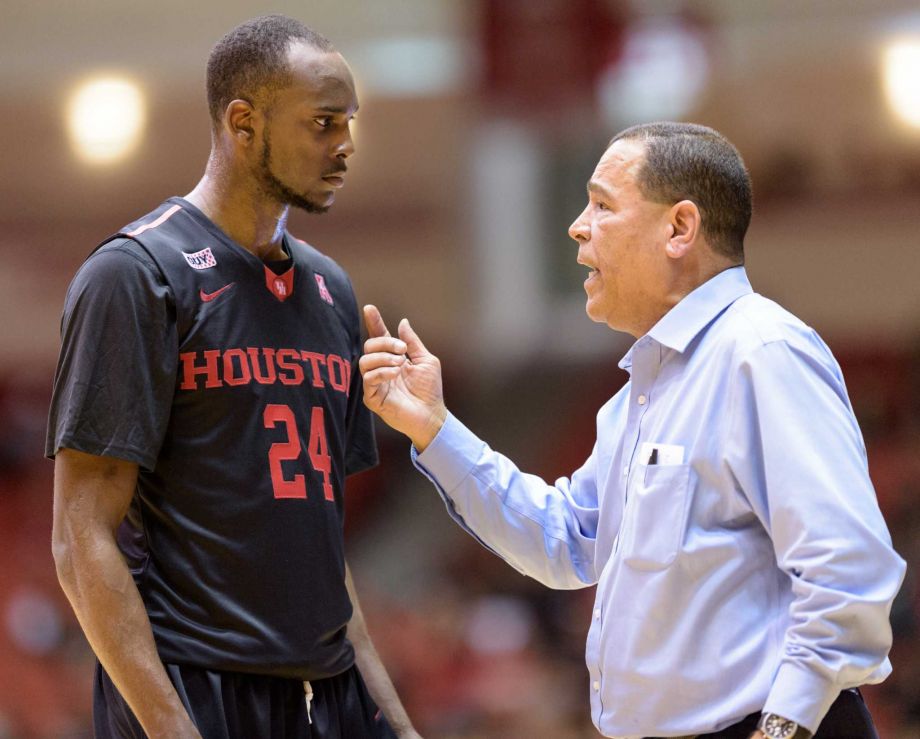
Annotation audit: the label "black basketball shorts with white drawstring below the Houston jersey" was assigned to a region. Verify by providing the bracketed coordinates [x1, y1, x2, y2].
[93, 663, 396, 739]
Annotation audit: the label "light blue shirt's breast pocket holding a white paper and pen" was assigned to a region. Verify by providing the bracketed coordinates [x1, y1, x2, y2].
[620, 464, 690, 570]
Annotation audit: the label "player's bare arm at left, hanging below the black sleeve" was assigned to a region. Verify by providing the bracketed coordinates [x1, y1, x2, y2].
[52, 449, 199, 737]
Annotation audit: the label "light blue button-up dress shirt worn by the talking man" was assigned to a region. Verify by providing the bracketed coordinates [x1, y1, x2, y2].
[413, 267, 905, 737]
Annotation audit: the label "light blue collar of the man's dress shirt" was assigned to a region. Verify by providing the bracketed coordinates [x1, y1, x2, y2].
[620, 266, 754, 369]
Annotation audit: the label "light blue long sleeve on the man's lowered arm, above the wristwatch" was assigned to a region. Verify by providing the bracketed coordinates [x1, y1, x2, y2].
[727, 335, 905, 731]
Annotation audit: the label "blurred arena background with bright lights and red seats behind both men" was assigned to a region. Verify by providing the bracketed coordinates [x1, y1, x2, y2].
[0, 0, 920, 739]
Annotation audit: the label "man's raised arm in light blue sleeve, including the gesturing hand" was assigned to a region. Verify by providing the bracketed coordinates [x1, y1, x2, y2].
[359, 305, 598, 588]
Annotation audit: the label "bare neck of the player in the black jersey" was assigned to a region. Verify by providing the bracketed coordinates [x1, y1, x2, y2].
[185, 172, 290, 262]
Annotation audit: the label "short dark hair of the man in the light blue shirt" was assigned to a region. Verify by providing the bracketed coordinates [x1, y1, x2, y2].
[608, 122, 753, 262]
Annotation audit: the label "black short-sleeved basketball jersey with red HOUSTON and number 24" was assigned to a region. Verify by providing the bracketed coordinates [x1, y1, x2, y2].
[47, 198, 377, 680]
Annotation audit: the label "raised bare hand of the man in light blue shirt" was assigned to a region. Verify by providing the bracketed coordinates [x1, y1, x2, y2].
[359, 305, 447, 451]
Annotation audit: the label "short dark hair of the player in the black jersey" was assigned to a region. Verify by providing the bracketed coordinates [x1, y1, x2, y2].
[207, 15, 335, 128]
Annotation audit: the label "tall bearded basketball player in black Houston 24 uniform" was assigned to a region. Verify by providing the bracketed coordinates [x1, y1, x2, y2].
[47, 16, 417, 739]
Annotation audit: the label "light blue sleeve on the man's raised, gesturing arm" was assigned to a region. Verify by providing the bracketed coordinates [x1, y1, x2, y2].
[412, 415, 598, 589]
